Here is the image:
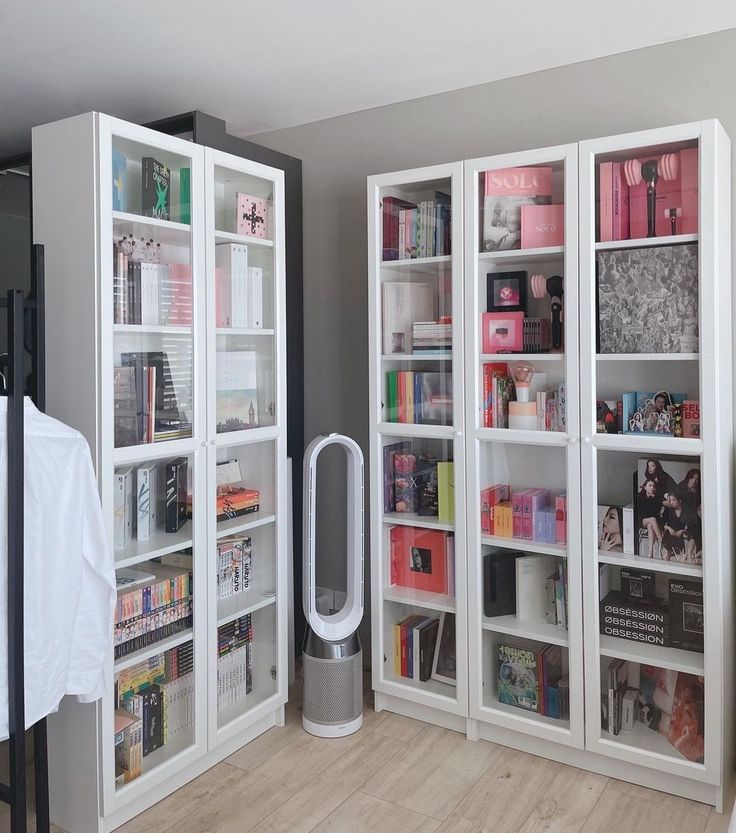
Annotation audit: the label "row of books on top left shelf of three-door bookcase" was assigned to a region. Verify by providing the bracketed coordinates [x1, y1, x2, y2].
[381, 191, 452, 260]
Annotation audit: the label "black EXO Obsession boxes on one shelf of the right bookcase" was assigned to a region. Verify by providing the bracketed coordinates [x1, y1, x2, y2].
[598, 564, 705, 654]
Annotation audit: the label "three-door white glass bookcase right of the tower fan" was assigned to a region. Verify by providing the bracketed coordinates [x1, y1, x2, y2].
[368, 121, 734, 810]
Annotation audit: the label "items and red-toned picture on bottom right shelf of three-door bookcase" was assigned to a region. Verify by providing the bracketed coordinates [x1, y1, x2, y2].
[601, 659, 705, 764]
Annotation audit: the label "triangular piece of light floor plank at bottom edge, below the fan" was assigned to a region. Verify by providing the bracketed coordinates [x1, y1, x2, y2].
[312, 790, 440, 833]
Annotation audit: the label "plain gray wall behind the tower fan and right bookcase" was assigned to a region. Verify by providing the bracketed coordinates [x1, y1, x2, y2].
[249, 30, 736, 648]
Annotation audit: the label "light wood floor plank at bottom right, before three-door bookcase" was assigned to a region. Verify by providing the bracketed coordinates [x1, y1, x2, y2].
[582, 779, 711, 833]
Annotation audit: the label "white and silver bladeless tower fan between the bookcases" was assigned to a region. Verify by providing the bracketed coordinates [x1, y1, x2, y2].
[302, 434, 363, 738]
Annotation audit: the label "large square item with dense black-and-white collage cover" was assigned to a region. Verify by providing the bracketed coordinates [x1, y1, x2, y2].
[597, 243, 699, 353]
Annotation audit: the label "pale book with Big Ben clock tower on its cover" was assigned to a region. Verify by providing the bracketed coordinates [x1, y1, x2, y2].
[216, 350, 258, 434]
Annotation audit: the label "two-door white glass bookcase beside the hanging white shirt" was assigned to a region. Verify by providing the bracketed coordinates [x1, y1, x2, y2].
[33, 113, 288, 833]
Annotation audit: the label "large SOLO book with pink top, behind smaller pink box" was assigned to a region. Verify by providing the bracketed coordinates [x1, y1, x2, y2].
[483, 167, 552, 252]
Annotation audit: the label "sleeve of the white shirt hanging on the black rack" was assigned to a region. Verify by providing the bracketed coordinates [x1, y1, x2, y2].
[67, 443, 116, 702]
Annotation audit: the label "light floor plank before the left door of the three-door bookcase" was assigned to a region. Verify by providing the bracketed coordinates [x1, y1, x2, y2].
[365, 724, 501, 821]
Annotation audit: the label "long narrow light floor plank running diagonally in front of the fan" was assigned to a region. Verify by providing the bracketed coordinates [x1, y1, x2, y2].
[247, 732, 403, 833]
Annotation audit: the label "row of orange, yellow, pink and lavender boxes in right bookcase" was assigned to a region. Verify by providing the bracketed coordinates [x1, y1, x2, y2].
[480, 483, 567, 544]
